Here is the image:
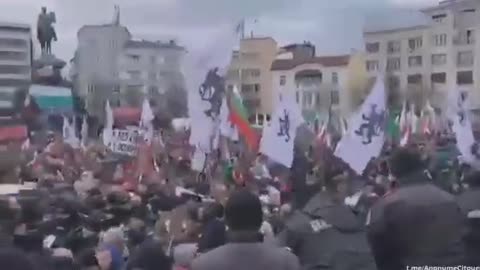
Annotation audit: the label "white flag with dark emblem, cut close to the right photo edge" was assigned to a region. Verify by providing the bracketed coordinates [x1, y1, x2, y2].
[448, 90, 477, 165]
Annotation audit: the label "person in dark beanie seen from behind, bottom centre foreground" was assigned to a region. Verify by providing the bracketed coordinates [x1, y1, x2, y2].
[191, 189, 300, 270]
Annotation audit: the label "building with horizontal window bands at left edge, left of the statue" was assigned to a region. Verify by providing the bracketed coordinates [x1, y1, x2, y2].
[0, 22, 32, 117]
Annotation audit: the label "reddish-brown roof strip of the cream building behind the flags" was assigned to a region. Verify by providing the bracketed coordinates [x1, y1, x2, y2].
[271, 55, 350, 70]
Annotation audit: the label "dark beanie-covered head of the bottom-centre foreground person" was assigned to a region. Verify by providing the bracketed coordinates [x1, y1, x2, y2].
[225, 189, 263, 232]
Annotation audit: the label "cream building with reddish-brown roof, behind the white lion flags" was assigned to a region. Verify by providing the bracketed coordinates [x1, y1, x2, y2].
[271, 43, 363, 126]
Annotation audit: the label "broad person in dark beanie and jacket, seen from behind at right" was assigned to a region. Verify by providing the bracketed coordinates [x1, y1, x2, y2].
[366, 148, 466, 270]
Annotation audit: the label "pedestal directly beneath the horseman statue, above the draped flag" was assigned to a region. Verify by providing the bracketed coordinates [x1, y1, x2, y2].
[32, 54, 67, 85]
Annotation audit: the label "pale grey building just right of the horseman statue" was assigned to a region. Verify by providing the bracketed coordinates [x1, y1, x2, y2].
[72, 23, 131, 116]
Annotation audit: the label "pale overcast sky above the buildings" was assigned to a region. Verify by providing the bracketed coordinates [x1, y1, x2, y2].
[0, 0, 438, 61]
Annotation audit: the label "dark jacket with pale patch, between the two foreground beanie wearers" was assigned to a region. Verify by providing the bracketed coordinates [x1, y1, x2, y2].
[278, 192, 376, 270]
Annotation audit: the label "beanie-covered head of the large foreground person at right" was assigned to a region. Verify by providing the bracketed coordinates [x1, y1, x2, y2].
[389, 148, 425, 179]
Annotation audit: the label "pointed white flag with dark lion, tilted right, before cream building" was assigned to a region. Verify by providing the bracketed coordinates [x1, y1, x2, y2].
[335, 76, 385, 174]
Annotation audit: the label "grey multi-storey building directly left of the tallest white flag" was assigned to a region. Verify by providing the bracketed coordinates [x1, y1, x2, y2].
[118, 40, 186, 105]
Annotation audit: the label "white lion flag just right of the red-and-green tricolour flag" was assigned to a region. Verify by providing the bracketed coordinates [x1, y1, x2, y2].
[260, 94, 304, 168]
